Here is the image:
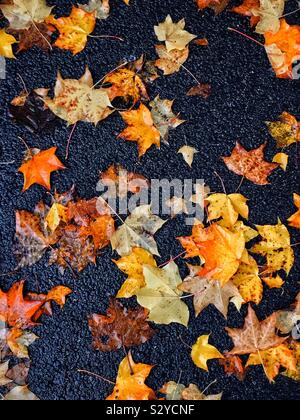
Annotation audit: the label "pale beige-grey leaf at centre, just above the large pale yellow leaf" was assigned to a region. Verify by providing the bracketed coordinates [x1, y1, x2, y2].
[111, 205, 166, 257]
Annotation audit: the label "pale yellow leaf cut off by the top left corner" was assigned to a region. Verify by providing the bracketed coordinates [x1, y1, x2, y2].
[0, 0, 53, 30]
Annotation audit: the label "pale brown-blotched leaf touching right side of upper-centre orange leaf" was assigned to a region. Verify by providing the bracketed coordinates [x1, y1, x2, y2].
[150, 95, 185, 144]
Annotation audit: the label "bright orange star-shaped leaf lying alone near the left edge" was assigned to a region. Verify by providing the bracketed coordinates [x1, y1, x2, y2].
[19, 147, 65, 192]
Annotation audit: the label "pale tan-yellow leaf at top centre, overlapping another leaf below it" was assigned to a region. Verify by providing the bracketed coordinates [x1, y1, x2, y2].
[154, 15, 197, 52]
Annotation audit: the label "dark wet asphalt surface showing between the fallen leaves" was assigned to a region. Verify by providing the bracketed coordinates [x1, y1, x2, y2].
[0, 0, 300, 400]
